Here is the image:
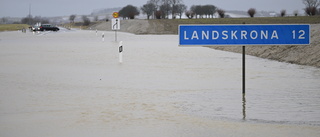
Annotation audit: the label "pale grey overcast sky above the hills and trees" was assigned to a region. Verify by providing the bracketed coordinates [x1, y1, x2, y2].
[0, 0, 305, 17]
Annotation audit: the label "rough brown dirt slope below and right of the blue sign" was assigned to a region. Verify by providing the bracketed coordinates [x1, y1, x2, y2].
[211, 24, 320, 68]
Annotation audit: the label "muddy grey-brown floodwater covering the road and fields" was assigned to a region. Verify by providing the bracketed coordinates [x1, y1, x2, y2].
[0, 29, 320, 137]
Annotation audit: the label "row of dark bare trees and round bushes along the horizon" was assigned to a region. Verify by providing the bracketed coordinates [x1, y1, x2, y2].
[119, 0, 320, 19]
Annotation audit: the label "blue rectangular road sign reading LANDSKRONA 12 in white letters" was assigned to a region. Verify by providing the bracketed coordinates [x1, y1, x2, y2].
[179, 25, 310, 46]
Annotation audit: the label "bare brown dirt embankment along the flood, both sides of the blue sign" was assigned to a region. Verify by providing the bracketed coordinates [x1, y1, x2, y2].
[91, 20, 320, 68]
